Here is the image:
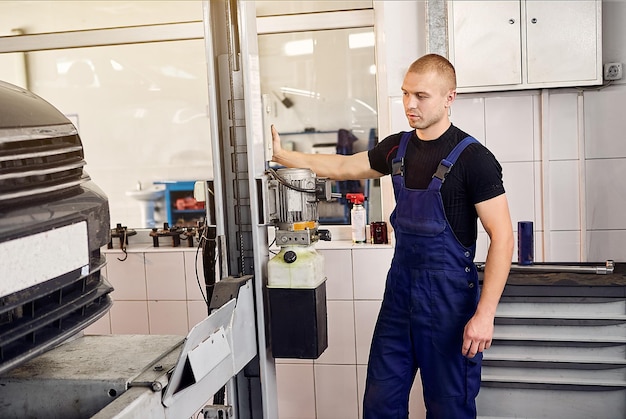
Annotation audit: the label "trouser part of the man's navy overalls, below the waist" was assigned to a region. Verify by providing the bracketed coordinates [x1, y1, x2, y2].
[363, 270, 482, 419]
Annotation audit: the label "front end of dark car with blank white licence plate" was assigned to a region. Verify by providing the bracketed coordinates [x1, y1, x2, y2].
[0, 82, 113, 373]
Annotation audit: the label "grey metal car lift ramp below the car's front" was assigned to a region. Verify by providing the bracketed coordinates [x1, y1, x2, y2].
[0, 276, 257, 419]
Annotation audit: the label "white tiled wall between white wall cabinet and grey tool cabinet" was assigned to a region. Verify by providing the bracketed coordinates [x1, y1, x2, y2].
[451, 84, 626, 262]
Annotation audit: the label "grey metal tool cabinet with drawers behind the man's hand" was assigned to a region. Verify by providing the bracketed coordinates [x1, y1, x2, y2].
[477, 264, 626, 419]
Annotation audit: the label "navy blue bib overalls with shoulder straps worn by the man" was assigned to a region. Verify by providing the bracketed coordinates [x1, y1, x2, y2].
[363, 132, 482, 419]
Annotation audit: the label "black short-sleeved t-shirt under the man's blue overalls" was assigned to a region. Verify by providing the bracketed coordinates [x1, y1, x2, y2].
[368, 125, 504, 246]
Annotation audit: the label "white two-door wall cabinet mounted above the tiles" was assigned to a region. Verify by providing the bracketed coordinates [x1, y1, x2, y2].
[448, 0, 602, 92]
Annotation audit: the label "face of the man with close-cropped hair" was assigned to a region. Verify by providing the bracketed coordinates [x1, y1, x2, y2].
[402, 72, 455, 130]
